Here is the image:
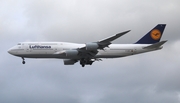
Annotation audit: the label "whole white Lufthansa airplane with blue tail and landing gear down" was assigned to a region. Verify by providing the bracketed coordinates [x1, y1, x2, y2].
[8, 24, 167, 67]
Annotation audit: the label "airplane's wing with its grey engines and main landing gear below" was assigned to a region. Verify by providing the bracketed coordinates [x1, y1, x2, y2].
[61, 30, 130, 67]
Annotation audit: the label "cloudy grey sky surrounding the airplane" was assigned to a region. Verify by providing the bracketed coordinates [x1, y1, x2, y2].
[0, 0, 180, 103]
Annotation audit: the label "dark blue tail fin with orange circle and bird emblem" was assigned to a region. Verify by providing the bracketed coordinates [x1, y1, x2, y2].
[136, 24, 166, 44]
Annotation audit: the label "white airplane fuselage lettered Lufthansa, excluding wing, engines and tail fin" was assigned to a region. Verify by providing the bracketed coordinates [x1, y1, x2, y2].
[8, 42, 161, 59]
